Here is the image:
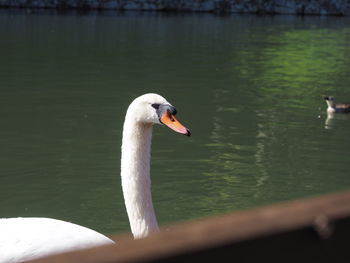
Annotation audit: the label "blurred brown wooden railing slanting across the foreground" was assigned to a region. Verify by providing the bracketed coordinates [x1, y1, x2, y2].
[26, 192, 350, 263]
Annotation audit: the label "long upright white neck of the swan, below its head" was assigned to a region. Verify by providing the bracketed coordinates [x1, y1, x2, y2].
[121, 120, 159, 238]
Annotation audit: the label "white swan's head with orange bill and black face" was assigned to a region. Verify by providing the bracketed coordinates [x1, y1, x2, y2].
[127, 93, 191, 136]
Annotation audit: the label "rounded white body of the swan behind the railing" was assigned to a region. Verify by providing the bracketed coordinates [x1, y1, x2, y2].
[0, 217, 114, 263]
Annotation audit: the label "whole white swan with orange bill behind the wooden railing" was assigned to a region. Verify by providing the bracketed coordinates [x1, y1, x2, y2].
[0, 94, 190, 263]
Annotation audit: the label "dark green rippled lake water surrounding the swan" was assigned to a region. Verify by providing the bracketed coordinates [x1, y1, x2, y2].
[0, 10, 350, 234]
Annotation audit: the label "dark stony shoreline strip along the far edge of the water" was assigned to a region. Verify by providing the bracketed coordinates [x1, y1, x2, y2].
[0, 0, 350, 16]
